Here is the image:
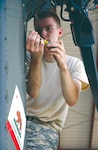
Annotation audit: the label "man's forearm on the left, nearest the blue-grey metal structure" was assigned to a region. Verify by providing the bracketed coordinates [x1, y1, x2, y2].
[26, 60, 42, 98]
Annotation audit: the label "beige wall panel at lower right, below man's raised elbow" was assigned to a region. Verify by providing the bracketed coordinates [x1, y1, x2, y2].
[60, 90, 93, 150]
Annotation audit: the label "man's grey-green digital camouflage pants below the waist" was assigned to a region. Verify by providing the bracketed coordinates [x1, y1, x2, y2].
[26, 121, 59, 150]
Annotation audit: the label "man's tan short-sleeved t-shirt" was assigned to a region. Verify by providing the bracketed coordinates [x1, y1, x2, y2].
[26, 55, 89, 131]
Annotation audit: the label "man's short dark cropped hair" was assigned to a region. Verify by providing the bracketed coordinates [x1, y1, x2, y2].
[34, 10, 61, 27]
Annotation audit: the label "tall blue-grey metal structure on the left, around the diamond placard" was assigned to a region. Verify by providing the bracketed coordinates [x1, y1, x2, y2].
[0, 0, 26, 150]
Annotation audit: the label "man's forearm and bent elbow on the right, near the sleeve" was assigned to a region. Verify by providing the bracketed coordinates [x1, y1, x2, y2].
[60, 69, 81, 106]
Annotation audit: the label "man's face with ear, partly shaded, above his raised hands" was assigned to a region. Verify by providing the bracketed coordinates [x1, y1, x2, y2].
[35, 17, 62, 43]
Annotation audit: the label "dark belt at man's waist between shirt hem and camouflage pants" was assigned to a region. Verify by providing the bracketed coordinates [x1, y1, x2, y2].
[26, 116, 56, 130]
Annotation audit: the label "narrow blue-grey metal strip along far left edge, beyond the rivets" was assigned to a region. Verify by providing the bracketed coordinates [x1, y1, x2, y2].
[0, 0, 6, 150]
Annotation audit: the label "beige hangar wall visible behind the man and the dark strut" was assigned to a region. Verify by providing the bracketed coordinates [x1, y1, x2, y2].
[58, 8, 98, 150]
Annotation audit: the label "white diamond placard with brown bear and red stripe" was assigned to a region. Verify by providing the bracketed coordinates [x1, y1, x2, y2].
[6, 86, 26, 150]
